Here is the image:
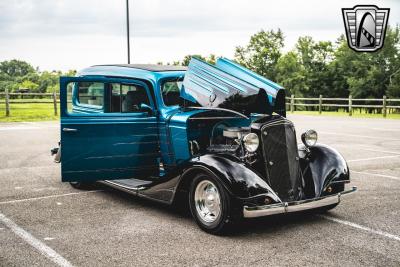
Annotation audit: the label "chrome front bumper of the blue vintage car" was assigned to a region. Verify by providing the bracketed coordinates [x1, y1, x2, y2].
[243, 186, 357, 218]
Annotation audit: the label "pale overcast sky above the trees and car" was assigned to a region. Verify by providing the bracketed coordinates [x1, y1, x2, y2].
[0, 0, 400, 70]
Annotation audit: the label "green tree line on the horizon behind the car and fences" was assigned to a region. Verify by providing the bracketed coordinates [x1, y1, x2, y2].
[0, 25, 400, 98]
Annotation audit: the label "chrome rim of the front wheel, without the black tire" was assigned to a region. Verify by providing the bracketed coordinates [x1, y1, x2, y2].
[194, 180, 221, 224]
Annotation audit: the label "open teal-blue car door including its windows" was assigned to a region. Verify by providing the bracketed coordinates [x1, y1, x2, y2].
[60, 77, 160, 182]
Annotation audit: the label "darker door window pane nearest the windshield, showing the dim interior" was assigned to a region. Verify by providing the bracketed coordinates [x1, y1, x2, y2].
[109, 83, 150, 113]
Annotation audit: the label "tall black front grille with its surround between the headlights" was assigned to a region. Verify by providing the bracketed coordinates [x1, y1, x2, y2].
[259, 117, 303, 201]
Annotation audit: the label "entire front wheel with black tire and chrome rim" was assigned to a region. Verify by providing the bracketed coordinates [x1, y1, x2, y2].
[189, 174, 233, 234]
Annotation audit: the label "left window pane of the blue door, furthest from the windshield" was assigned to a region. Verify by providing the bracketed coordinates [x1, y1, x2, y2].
[67, 82, 105, 114]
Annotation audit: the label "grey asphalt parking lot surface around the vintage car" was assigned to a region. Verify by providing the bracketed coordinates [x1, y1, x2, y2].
[0, 115, 400, 266]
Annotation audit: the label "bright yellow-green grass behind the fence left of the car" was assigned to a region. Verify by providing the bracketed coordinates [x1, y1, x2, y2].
[0, 103, 60, 122]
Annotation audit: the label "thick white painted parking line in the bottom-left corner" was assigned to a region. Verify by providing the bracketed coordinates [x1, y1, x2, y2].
[0, 213, 72, 267]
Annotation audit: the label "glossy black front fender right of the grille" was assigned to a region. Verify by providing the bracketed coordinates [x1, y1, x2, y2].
[299, 144, 350, 197]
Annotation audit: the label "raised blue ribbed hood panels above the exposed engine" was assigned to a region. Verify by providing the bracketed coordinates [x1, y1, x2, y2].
[181, 58, 286, 116]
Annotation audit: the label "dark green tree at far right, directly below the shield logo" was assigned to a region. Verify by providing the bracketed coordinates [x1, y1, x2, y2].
[332, 26, 400, 98]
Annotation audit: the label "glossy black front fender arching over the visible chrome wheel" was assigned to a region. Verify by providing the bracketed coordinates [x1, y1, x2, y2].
[182, 154, 280, 202]
